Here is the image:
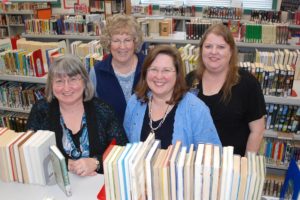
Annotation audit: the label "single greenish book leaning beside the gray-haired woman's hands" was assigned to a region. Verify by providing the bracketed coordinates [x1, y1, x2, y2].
[50, 145, 72, 196]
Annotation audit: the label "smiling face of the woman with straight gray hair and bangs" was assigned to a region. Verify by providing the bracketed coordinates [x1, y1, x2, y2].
[52, 75, 85, 105]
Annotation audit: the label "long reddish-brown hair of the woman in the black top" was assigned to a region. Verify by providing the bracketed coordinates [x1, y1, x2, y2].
[197, 24, 240, 103]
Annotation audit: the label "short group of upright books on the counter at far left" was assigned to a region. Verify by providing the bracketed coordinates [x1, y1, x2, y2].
[0, 128, 56, 185]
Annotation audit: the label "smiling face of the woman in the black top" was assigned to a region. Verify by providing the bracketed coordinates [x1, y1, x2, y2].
[202, 33, 232, 73]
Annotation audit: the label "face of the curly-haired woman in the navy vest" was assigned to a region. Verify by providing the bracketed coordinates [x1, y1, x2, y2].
[110, 33, 135, 64]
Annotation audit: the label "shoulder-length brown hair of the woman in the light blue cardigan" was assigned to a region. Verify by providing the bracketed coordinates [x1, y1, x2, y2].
[136, 45, 187, 104]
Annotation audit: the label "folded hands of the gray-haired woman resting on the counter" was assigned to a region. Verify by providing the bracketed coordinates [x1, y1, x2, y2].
[68, 158, 97, 176]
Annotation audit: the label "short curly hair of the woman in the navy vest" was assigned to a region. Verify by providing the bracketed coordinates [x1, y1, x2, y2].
[100, 14, 143, 52]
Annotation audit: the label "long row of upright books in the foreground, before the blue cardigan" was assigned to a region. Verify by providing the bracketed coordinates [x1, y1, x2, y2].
[103, 133, 266, 200]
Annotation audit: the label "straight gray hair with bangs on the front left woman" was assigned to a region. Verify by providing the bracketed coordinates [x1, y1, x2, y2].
[45, 54, 94, 102]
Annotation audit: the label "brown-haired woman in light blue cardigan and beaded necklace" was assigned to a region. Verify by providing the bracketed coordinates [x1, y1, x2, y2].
[123, 45, 221, 148]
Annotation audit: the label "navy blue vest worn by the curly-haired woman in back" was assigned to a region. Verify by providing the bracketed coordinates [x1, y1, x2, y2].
[90, 53, 145, 123]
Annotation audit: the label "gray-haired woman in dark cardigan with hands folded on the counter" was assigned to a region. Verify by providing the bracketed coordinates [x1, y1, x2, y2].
[26, 55, 128, 176]
